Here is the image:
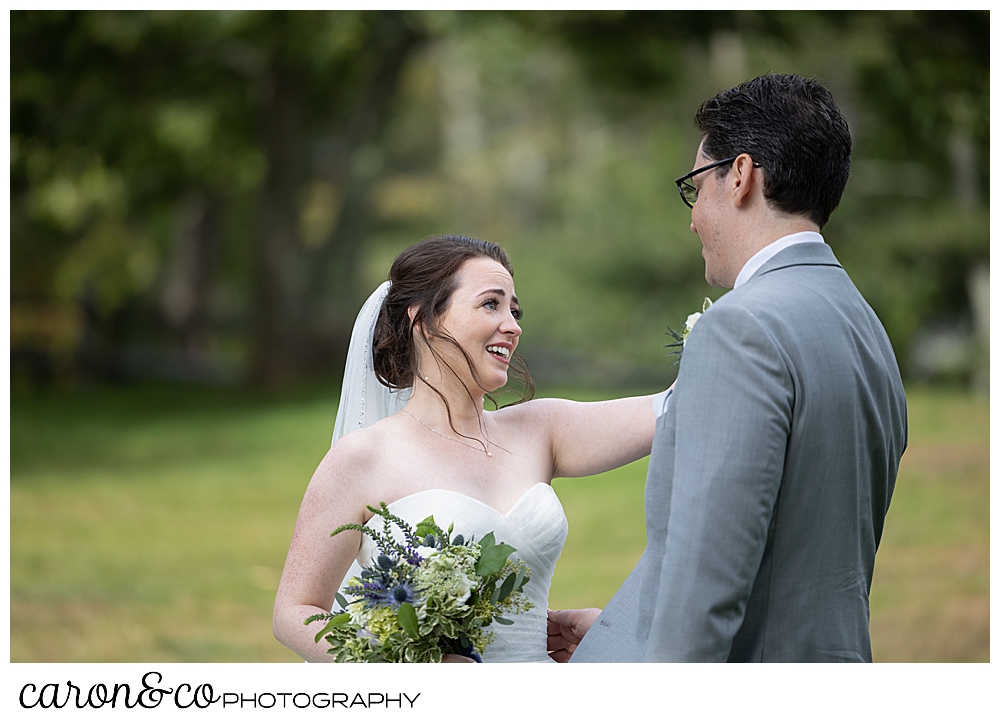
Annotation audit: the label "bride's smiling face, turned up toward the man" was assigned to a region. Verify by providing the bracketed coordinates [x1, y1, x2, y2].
[423, 258, 521, 392]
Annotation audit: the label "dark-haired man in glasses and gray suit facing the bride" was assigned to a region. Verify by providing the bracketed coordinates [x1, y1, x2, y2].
[549, 75, 906, 662]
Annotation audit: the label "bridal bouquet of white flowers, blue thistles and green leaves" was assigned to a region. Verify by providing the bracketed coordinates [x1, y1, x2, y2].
[306, 502, 533, 663]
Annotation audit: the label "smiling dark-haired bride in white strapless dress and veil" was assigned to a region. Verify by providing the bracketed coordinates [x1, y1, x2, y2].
[274, 236, 654, 662]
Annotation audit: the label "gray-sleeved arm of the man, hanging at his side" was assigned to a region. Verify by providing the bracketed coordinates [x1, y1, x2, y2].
[646, 304, 793, 662]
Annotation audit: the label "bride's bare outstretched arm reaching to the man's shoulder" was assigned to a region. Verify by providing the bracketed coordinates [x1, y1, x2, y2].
[525, 396, 656, 477]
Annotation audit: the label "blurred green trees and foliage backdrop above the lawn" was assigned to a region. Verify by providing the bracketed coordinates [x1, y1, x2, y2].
[11, 11, 989, 388]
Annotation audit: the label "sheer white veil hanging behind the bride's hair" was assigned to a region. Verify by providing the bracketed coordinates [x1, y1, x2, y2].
[331, 281, 413, 444]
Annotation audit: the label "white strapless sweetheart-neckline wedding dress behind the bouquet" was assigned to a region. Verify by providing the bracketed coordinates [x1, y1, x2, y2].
[347, 483, 569, 663]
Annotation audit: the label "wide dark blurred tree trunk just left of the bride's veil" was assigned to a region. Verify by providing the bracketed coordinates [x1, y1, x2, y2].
[250, 12, 423, 386]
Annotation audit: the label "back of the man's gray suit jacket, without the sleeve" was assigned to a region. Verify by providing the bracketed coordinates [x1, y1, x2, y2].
[727, 245, 906, 661]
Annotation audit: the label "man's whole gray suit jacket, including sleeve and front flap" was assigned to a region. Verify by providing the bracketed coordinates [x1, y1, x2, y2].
[572, 243, 907, 662]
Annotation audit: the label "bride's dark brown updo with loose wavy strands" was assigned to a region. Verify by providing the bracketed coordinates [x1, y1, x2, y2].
[372, 236, 534, 408]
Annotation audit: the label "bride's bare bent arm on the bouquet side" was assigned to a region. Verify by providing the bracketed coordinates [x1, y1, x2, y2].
[273, 433, 373, 663]
